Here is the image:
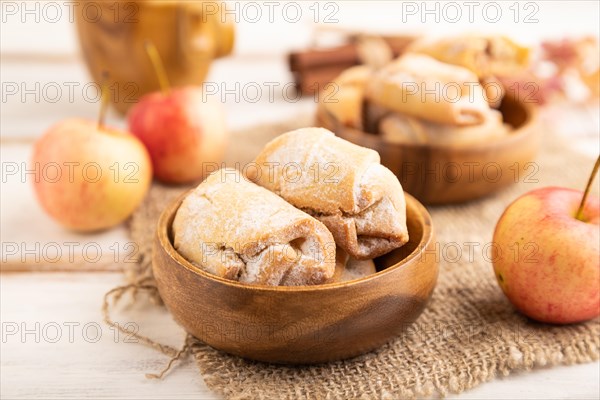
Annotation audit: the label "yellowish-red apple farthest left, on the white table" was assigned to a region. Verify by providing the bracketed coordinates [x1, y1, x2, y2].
[29, 119, 152, 231]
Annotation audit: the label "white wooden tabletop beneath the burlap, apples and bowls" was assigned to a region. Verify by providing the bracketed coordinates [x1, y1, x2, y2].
[0, 2, 600, 399]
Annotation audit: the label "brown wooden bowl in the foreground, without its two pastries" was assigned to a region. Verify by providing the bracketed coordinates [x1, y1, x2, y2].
[152, 195, 438, 364]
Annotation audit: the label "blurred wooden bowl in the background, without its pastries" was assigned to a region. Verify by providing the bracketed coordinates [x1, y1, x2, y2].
[317, 96, 541, 204]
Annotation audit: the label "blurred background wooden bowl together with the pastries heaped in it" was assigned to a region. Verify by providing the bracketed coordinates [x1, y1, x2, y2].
[316, 39, 542, 204]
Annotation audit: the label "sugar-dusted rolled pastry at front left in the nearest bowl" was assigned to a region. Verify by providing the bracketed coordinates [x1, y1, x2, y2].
[173, 169, 335, 285]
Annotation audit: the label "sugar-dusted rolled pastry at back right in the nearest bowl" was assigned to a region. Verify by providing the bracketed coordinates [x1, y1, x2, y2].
[252, 128, 408, 259]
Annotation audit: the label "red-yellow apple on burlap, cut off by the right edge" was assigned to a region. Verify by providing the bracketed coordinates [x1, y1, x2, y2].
[493, 187, 600, 324]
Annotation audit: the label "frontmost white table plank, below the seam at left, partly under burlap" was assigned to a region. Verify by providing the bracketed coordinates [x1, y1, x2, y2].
[0, 273, 600, 399]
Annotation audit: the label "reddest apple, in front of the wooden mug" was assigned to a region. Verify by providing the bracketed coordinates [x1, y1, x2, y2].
[128, 87, 227, 183]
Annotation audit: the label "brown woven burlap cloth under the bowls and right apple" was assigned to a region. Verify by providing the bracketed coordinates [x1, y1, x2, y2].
[119, 117, 600, 399]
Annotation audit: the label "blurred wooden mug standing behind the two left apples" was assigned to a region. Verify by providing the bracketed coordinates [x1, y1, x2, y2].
[75, 0, 234, 113]
